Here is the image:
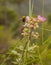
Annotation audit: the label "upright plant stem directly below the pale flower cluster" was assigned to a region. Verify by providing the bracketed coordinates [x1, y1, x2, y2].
[22, 37, 29, 65]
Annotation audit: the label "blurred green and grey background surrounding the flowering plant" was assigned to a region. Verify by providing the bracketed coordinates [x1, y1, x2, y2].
[0, 0, 51, 65]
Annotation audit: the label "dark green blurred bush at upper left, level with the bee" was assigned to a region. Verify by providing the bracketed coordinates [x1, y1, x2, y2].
[0, 6, 17, 24]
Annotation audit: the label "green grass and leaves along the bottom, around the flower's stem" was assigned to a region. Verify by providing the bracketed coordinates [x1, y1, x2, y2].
[1, 39, 51, 65]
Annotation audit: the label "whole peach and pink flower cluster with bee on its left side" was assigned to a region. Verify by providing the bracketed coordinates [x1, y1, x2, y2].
[21, 15, 46, 39]
